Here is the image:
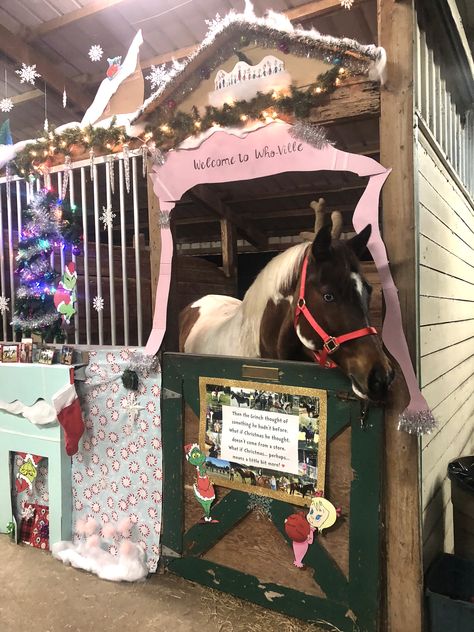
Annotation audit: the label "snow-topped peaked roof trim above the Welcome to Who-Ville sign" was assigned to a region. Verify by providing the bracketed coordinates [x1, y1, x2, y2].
[131, 0, 386, 123]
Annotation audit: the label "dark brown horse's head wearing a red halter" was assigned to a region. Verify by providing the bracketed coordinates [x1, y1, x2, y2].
[293, 215, 394, 402]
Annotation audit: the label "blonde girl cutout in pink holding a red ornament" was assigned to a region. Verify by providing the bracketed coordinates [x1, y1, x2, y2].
[285, 496, 341, 568]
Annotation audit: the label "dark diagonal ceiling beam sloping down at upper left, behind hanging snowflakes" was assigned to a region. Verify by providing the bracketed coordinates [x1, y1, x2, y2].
[0, 24, 92, 112]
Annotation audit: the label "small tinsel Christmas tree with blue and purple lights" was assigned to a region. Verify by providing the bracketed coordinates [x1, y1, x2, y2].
[12, 189, 82, 341]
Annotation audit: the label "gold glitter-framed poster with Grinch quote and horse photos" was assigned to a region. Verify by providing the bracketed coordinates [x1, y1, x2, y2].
[199, 376, 327, 505]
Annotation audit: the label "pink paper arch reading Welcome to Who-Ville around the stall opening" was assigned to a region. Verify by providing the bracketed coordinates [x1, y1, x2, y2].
[146, 121, 436, 432]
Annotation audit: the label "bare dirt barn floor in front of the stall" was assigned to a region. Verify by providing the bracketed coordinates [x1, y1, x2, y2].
[0, 535, 326, 632]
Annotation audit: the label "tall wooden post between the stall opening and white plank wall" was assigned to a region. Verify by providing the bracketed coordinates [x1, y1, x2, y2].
[377, 0, 423, 632]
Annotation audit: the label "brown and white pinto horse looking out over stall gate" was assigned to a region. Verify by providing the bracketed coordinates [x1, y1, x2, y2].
[179, 215, 394, 402]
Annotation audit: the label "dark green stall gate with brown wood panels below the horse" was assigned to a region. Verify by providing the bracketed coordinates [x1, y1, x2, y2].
[162, 353, 383, 632]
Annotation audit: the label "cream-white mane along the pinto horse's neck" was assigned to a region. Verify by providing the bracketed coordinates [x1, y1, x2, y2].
[241, 242, 308, 349]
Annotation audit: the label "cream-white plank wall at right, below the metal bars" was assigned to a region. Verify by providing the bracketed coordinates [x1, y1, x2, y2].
[416, 133, 474, 567]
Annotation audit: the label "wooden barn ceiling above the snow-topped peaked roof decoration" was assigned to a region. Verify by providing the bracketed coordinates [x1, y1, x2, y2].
[0, 0, 377, 142]
